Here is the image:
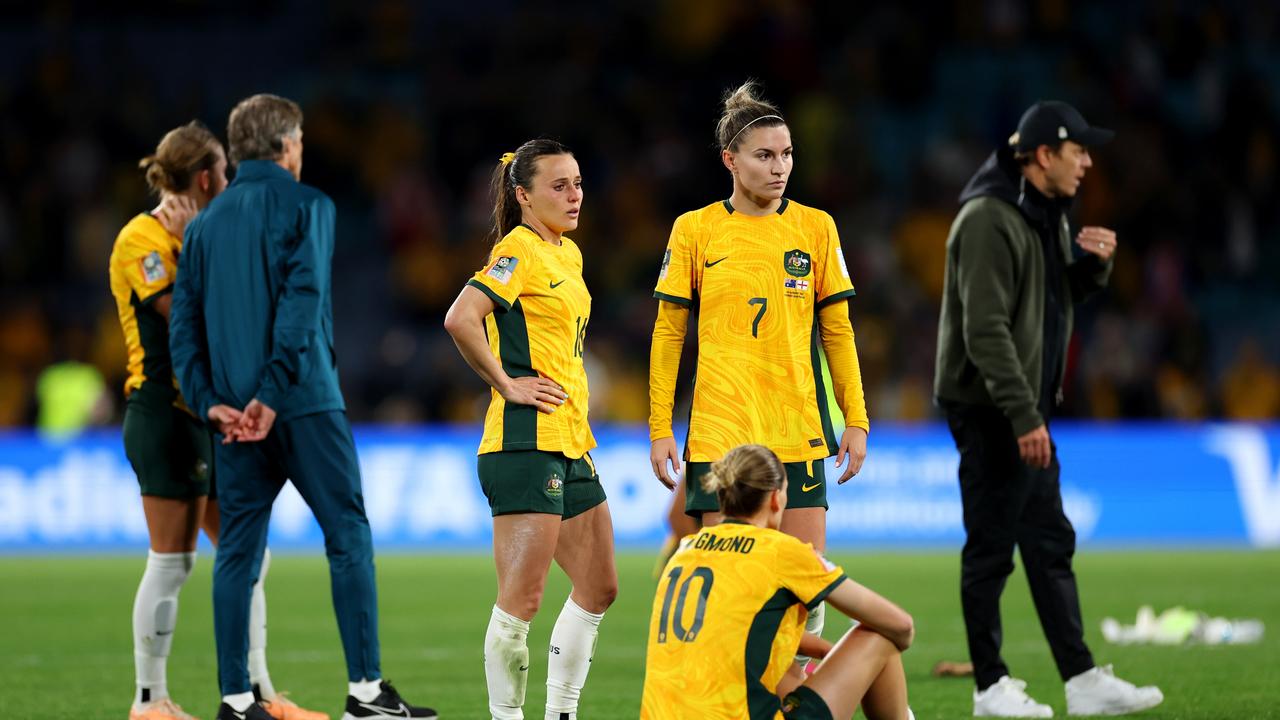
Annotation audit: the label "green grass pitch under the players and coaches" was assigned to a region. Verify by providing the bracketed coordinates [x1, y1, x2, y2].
[0, 550, 1280, 720]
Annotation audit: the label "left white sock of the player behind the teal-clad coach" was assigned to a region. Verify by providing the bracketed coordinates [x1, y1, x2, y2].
[133, 551, 196, 705]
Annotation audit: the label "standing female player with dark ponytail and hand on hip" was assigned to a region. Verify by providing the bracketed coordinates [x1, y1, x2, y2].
[444, 138, 618, 720]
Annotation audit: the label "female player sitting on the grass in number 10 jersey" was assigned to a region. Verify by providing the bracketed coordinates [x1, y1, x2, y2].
[640, 445, 915, 720]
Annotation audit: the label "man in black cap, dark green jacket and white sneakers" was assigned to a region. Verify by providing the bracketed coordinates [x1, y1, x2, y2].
[933, 101, 1164, 717]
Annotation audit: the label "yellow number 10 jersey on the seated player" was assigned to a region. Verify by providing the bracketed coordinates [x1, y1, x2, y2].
[640, 520, 846, 720]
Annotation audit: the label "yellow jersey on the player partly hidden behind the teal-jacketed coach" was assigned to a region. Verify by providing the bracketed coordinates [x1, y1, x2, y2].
[109, 213, 183, 406]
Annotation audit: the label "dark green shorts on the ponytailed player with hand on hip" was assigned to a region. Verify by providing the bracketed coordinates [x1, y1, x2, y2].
[476, 450, 605, 520]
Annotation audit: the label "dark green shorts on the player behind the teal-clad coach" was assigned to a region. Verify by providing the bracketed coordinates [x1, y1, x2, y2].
[124, 384, 214, 500]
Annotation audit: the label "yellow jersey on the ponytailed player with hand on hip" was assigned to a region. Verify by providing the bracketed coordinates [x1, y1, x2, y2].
[467, 224, 595, 459]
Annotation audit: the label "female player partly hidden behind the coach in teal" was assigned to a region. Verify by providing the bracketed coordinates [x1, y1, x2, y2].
[109, 122, 328, 720]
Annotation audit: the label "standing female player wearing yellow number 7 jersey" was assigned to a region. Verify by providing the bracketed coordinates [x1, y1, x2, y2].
[649, 82, 870, 650]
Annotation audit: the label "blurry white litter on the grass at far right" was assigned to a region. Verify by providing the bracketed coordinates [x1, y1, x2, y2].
[1102, 605, 1266, 644]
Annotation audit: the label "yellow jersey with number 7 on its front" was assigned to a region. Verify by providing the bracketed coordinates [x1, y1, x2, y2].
[654, 199, 860, 462]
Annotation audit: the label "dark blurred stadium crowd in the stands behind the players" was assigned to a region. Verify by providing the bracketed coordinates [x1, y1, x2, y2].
[0, 0, 1280, 427]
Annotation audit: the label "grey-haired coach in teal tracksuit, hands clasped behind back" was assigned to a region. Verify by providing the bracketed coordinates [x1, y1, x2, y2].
[170, 95, 434, 717]
